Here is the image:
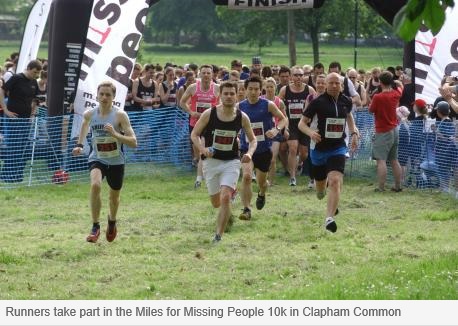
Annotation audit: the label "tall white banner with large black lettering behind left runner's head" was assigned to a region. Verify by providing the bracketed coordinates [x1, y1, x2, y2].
[74, 0, 150, 116]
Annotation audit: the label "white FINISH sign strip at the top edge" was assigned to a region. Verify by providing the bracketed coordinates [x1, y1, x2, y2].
[213, 0, 324, 10]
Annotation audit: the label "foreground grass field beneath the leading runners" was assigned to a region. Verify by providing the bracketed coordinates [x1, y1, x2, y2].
[0, 174, 458, 300]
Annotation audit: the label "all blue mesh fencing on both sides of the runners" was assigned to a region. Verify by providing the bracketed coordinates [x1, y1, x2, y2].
[0, 108, 458, 194]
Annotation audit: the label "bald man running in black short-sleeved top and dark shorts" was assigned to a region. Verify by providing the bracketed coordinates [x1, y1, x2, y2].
[299, 73, 359, 232]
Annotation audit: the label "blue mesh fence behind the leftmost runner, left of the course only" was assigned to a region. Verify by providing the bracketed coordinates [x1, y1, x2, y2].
[0, 108, 192, 188]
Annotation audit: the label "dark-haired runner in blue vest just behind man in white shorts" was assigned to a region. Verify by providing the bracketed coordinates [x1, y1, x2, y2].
[239, 77, 288, 220]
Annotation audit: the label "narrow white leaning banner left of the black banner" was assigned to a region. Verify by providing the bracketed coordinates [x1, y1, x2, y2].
[16, 0, 53, 73]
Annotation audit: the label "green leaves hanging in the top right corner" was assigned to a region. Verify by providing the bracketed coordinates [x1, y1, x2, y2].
[393, 0, 455, 41]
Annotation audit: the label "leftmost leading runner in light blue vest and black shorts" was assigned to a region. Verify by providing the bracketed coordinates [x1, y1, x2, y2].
[72, 82, 137, 243]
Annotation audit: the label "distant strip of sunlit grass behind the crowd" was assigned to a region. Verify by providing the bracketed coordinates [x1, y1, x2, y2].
[0, 41, 403, 69]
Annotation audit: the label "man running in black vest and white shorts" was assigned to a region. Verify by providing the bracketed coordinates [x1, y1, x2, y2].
[191, 81, 257, 243]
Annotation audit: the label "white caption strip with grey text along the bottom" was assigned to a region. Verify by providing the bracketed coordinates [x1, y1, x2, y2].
[0, 300, 458, 326]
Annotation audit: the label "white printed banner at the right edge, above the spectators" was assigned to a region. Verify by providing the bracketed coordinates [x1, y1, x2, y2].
[415, 6, 458, 104]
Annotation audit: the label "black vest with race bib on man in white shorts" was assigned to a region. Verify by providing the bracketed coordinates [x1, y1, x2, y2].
[203, 107, 242, 161]
